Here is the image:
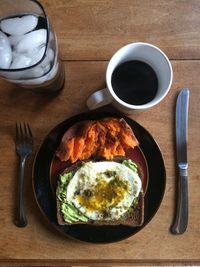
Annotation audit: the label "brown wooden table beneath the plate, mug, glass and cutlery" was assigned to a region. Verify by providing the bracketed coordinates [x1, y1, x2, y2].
[0, 0, 200, 266]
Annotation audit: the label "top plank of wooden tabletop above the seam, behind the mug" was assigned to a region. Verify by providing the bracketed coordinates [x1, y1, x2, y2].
[41, 0, 200, 60]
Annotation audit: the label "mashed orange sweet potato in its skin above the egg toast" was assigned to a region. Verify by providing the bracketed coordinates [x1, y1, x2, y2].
[56, 118, 138, 163]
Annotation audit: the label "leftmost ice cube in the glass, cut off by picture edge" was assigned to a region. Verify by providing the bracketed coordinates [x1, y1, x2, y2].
[0, 31, 12, 69]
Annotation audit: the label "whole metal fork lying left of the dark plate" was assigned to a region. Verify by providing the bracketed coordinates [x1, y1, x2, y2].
[15, 122, 33, 227]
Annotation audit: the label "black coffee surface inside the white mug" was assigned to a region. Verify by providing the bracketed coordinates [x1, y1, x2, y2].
[111, 60, 158, 105]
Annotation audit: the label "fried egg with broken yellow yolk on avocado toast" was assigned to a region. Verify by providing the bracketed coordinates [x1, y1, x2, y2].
[66, 161, 142, 221]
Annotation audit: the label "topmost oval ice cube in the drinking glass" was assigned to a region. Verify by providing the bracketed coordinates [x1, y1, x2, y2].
[0, 15, 38, 35]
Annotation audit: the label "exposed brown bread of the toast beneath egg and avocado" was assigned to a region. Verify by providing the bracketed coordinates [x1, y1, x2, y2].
[56, 157, 144, 227]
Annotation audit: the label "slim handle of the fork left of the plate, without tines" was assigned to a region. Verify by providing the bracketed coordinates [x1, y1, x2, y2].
[15, 157, 27, 227]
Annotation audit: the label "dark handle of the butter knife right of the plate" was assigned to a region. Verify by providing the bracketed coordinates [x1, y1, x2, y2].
[171, 170, 188, 234]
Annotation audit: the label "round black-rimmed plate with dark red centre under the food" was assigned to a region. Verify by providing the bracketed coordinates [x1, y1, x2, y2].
[33, 112, 166, 243]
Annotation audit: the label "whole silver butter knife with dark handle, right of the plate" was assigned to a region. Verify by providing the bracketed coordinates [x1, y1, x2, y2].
[171, 88, 189, 234]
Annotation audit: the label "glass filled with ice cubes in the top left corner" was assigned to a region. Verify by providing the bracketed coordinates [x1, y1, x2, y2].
[0, 0, 65, 92]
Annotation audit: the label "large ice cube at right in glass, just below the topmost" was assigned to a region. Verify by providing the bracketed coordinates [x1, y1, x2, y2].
[16, 29, 47, 54]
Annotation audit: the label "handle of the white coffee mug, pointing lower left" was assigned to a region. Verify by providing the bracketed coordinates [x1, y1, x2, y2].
[86, 88, 113, 110]
